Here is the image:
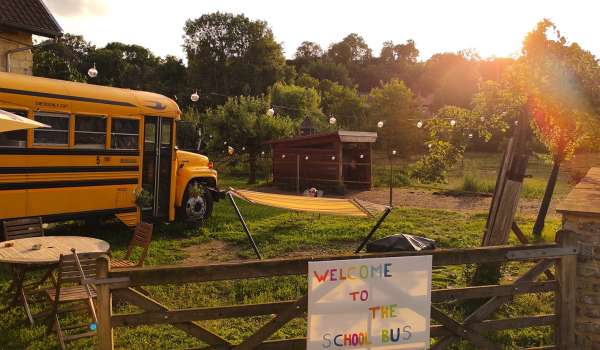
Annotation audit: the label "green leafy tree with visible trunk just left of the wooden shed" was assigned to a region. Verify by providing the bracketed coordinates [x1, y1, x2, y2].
[207, 96, 294, 184]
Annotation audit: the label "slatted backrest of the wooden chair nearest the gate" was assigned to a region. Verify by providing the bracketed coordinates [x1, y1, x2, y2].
[58, 252, 103, 285]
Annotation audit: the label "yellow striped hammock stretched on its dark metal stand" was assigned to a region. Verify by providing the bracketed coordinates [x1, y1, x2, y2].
[227, 188, 391, 259]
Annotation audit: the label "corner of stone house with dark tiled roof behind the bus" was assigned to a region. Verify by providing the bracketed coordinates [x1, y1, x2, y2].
[0, 0, 62, 75]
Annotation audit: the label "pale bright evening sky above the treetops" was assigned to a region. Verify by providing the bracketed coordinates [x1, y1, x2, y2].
[43, 0, 600, 60]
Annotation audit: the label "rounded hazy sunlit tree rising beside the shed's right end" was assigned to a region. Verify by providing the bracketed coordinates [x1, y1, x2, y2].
[367, 79, 420, 154]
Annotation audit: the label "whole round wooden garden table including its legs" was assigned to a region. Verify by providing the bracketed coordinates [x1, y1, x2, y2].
[0, 236, 110, 325]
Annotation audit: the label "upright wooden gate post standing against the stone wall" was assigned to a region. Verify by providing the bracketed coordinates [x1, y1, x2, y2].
[555, 230, 577, 350]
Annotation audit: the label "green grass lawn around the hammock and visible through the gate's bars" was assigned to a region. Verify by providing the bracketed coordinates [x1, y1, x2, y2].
[0, 152, 570, 349]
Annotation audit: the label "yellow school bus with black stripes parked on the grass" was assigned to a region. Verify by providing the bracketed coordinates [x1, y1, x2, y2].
[0, 73, 217, 226]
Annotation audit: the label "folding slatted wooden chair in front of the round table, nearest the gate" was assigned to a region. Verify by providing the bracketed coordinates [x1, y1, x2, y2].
[46, 249, 102, 349]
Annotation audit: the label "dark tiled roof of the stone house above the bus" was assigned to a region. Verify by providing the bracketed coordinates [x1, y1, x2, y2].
[0, 0, 62, 38]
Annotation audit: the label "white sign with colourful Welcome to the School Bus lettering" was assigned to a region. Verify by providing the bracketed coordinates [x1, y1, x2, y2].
[307, 255, 431, 350]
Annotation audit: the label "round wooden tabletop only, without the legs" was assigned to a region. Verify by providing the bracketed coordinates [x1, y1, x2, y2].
[0, 236, 110, 265]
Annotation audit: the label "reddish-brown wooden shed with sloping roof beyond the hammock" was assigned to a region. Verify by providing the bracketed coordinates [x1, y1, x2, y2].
[265, 131, 377, 191]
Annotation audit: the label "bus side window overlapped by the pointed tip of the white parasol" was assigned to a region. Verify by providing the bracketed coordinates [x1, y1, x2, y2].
[33, 112, 69, 146]
